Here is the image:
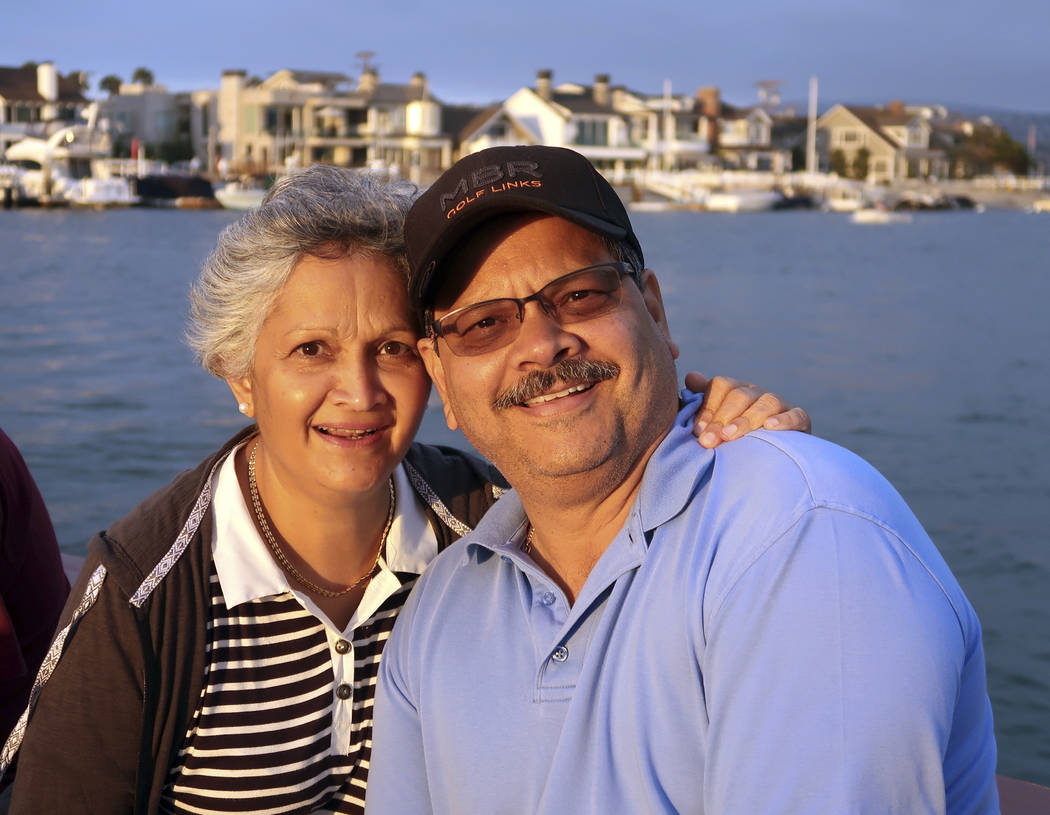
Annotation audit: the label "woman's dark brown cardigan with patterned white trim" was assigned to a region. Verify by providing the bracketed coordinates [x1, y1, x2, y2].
[11, 427, 505, 815]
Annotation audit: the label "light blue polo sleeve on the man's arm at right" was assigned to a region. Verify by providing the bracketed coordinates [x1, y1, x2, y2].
[701, 508, 995, 813]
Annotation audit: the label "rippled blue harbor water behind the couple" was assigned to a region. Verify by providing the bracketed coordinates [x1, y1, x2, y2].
[0, 209, 1050, 785]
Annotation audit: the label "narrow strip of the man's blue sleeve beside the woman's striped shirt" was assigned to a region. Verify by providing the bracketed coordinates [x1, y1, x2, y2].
[364, 585, 434, 815]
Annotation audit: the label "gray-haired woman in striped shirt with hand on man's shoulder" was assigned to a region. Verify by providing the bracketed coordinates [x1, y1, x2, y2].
[7, 167, 806, 813]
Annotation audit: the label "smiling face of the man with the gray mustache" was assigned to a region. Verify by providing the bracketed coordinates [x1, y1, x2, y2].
[420, 215, 677, 488]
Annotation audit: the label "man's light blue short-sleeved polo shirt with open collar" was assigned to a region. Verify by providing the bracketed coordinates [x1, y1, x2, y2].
[368, 390, 999, 815]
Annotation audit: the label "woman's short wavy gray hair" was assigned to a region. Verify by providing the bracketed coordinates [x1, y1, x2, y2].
[186, 164, 418, 379]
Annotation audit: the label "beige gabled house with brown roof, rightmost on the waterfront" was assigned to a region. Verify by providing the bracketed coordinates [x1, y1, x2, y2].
[817, 103, 948, 183]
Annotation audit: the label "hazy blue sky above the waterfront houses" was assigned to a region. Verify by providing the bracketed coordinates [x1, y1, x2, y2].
[8, 0, 1050, 112]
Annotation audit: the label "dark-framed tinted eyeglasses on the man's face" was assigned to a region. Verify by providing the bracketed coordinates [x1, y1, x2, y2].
[431, 263, 637, 356]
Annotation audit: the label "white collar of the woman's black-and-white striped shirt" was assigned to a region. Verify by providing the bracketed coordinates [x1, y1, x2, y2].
[211, 451, 438, 608]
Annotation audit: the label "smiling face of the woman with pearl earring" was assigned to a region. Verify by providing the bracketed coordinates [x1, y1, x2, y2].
[227, 254, 431, 503]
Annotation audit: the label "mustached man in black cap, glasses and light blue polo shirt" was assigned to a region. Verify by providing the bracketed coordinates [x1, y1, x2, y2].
[368, 147, 998, 815]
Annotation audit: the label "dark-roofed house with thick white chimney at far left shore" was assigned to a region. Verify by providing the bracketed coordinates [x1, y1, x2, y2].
[0, 61, 89, 156]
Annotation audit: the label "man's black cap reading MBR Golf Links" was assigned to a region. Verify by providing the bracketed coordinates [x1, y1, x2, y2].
[404, 145, 644, 308]
